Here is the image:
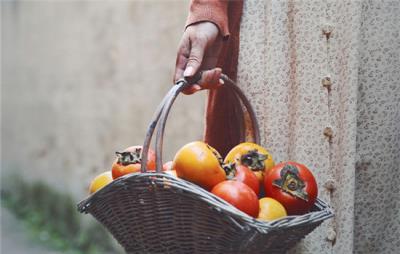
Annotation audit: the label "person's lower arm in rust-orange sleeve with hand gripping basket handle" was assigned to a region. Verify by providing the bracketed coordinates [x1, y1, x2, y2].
[174, 0, 229, 94]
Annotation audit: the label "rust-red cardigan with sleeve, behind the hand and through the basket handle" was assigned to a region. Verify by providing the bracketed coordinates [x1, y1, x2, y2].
[186, 0, 244, 156]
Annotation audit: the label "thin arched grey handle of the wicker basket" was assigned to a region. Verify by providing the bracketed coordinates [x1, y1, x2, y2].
[140, 74, 260, 173]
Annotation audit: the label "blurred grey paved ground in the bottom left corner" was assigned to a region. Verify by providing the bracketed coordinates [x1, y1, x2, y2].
[0, 207, 62, 254]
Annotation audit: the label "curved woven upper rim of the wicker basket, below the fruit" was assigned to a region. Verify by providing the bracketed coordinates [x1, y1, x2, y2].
[77, 172, 334, 232]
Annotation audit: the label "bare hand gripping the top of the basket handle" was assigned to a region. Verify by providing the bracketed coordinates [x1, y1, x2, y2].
[174, 22, 223, 94]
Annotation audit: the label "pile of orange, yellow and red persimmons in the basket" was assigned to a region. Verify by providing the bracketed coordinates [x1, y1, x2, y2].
[90, 141, 318, 221]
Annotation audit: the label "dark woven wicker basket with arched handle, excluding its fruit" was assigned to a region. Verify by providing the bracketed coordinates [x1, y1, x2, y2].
[78, 75, 333, 254]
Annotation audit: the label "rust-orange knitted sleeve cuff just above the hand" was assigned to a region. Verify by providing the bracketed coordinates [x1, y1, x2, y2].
[185, 0, 229, 39]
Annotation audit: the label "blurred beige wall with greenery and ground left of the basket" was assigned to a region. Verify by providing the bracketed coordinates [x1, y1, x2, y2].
[1, 0, 205, 254]
